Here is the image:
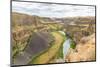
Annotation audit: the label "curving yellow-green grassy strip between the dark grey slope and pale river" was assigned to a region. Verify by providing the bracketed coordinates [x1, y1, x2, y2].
[29, 32, 64, 64]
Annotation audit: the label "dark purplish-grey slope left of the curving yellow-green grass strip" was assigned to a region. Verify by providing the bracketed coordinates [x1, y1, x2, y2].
[14, 32, 51, 65]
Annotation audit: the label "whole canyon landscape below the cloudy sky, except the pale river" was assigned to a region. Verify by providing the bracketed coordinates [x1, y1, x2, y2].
[11, 12, 96, 65]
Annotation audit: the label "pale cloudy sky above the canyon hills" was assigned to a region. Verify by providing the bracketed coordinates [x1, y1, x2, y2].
[12, 1, 95, 18]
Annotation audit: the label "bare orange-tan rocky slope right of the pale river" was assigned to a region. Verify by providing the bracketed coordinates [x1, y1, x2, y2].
[66, 34, 96, 62]
